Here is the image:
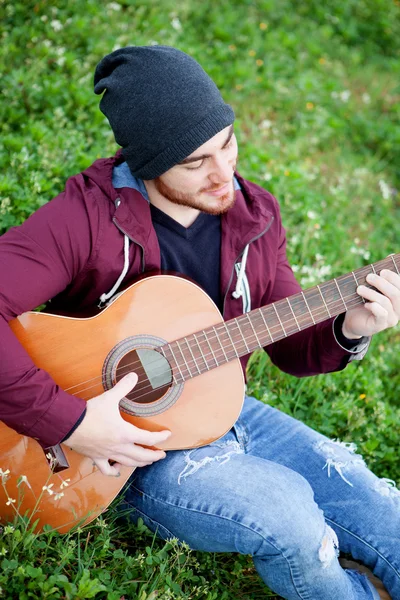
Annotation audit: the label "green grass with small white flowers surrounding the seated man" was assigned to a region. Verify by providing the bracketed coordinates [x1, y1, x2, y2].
[0, 0, 400, 600]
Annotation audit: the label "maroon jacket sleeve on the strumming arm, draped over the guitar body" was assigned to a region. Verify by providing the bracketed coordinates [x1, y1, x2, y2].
[0, 176, 99, 447]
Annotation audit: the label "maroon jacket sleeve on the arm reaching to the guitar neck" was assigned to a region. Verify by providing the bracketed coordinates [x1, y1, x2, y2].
[264, 212, 368, 377]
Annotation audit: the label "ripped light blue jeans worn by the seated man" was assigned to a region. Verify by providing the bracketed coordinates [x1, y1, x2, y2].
[125, 397, 400, 600]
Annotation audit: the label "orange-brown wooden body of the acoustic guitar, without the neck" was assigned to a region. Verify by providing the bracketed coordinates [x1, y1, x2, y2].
[0, 275, 244, 532]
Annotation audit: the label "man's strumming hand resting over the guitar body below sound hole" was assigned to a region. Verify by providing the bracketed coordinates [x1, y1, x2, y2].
[64, 373, 171, 476]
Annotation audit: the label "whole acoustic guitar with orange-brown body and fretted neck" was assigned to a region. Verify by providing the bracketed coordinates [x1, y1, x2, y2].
[0, 254, 400, 532]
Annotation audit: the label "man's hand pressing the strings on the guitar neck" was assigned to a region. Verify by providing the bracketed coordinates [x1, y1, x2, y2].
[342, 269, 400, 339]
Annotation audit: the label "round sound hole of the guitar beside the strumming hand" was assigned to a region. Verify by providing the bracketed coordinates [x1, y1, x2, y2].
[116, 348, 172, 404]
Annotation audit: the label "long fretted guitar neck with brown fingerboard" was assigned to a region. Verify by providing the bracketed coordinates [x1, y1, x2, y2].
[161, 254, 400, 384]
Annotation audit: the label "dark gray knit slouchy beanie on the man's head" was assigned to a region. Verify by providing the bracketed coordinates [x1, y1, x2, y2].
[94, 46, 235, 179]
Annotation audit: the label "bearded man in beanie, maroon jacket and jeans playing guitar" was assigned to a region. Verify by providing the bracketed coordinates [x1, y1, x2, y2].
[0, 46, 400, 600]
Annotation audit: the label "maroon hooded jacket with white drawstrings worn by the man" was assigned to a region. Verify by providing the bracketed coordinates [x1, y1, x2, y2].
[0, 153, 351, 446]
